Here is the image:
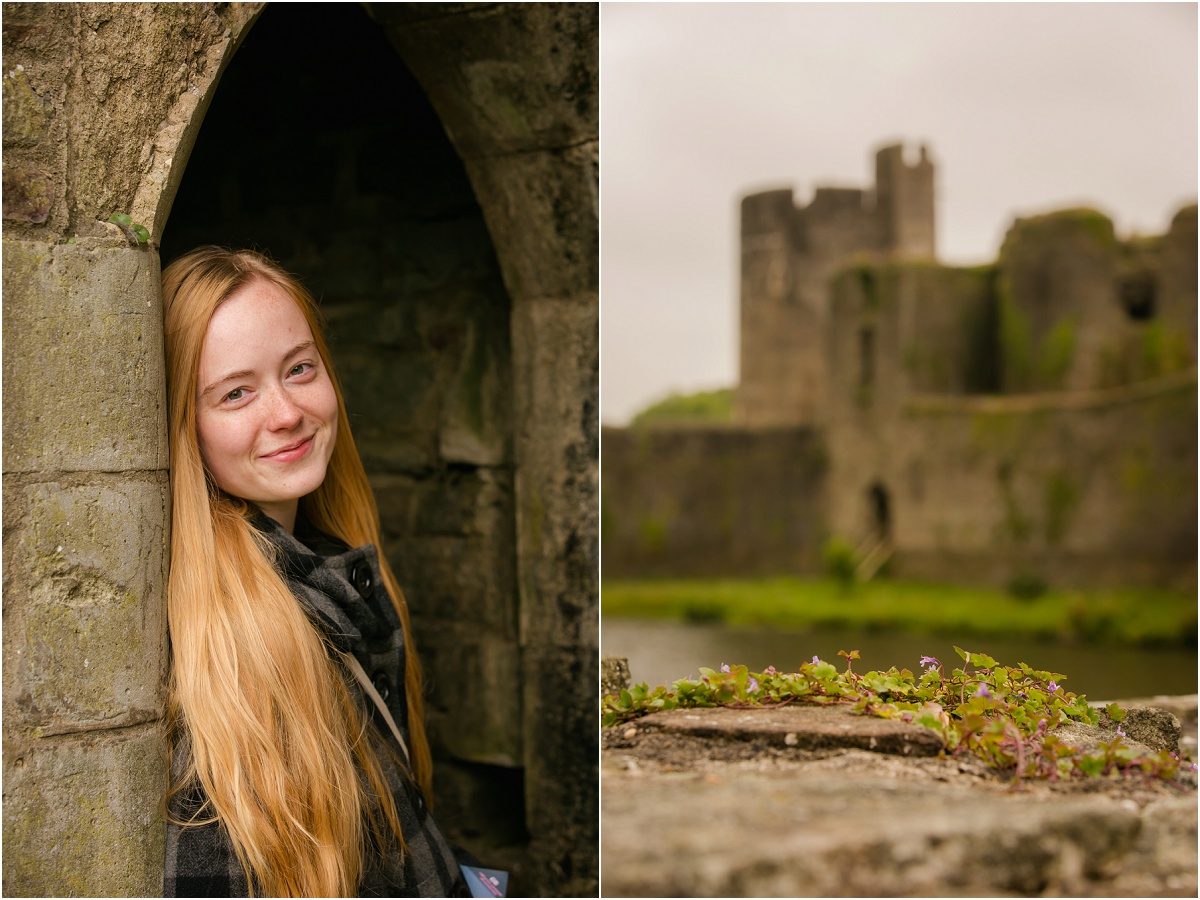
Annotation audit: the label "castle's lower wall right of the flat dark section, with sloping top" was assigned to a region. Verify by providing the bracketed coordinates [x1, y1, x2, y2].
[830, 373, 1196, 590]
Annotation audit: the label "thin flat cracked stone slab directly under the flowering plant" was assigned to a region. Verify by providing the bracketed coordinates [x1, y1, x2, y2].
[634, 703, 942, 757]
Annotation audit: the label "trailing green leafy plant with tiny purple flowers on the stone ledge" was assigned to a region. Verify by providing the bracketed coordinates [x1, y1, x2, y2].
[600, 647, 1195, 780]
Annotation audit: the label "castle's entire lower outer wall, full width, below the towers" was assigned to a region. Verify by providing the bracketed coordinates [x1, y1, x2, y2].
[601, 372, 1196, 589]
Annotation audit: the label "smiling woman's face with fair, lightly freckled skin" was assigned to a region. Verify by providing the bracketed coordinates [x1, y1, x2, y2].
[196, 281, 337, 530]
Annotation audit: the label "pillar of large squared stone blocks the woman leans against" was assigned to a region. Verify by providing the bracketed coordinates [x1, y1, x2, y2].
[4, 239, 168, 896]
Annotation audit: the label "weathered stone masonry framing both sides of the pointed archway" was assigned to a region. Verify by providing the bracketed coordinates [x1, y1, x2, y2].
[4, 4, 599, 895]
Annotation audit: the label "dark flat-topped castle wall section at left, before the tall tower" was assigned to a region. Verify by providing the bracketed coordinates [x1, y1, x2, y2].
[600, 427, 828, 578]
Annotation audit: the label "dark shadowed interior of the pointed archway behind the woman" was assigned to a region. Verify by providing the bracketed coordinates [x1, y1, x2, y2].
[161, 4, 528, 865]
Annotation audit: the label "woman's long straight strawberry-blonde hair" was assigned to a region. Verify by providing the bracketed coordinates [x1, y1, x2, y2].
[162, 247, 432, 896]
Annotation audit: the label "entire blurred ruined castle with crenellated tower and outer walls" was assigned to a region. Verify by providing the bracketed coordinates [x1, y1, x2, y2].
[601, 145, 1196, 588]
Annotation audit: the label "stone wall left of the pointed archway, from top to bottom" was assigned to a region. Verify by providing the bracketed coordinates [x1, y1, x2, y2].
[2, 4, 257, 896]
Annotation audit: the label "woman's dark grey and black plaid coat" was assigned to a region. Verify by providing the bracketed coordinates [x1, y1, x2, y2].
[163, 515, 472, 896]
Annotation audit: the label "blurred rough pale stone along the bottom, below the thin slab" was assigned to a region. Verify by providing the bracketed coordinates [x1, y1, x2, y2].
[601, 768, 1196, 896]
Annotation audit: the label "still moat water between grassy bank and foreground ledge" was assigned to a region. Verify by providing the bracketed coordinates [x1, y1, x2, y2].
[600, 617, 1198, 700]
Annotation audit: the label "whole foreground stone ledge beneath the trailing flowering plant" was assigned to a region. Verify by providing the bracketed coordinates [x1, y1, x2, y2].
[601, 698, 1198, 896]
